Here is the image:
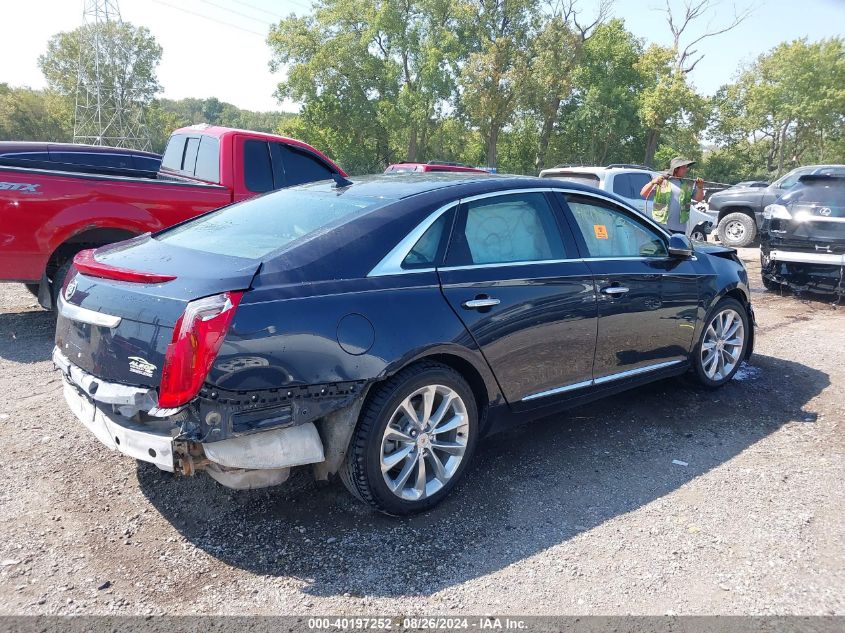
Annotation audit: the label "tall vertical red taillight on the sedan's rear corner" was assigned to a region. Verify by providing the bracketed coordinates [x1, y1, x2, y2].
[158, 291, 244, 409]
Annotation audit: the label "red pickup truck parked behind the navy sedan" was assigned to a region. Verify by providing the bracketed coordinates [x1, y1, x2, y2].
[0, 125, 346, 307]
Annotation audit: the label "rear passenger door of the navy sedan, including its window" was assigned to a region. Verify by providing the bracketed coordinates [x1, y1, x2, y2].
[438, 190, 597, 406]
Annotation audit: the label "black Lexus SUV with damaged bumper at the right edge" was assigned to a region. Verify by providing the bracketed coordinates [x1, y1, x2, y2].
[760, 174, 845, 297]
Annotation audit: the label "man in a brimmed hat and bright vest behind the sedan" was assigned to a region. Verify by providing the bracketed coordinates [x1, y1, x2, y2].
[640, 156, 704, 233]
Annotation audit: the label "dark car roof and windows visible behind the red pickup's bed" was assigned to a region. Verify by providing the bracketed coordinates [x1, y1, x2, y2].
[0, 141, 161, 178]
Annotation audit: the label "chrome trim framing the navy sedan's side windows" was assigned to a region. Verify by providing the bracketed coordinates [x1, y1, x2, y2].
[367, 187, 669, 277]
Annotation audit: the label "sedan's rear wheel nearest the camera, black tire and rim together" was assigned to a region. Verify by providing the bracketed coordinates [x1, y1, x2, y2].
[341, 362, 478, 515]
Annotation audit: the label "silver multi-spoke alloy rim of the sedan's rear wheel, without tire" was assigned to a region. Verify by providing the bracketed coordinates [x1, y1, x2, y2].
[380, 385, 469, 501]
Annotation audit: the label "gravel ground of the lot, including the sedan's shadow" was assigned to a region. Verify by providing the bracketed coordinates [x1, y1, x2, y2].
[0, 249, 845, 615]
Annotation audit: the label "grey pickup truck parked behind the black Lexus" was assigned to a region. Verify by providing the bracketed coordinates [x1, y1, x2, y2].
[708, 165, 845, 247]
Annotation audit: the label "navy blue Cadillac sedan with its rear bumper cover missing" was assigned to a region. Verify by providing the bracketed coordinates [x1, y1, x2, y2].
[53, 174, 754, 514]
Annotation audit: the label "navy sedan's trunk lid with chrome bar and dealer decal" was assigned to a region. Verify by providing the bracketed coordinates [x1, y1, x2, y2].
[56, 235, 261, 387]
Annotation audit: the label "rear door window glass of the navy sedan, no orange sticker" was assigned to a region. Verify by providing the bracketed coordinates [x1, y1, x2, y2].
[447, 193, 566, 266]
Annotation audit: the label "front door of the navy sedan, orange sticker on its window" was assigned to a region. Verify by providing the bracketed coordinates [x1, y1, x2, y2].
[560, 193, 699, 384]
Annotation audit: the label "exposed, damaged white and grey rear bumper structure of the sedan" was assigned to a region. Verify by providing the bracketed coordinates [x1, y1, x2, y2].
[53, 348, 336, 489]
